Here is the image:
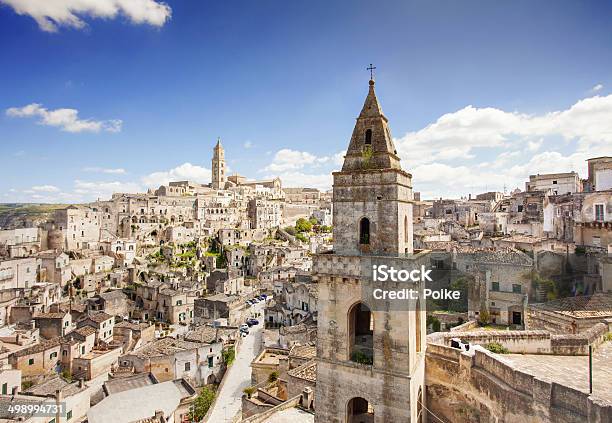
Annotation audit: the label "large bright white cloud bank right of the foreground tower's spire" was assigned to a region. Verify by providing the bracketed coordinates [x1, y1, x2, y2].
[395, 95, 612, 167]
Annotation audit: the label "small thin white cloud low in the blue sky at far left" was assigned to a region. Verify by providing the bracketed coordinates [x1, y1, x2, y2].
[6, 103, 122, 132]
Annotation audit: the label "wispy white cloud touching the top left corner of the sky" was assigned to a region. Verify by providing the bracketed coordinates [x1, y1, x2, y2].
[0, 0, 172, 32]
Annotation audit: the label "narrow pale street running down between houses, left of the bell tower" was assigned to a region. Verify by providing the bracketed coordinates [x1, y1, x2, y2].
[206, 303, 264, 423]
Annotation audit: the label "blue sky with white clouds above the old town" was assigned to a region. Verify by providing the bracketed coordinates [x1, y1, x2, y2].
[0, 0, 612, 203]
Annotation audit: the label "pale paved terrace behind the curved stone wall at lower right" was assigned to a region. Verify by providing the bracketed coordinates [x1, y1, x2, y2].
[502, 342, 612, 401]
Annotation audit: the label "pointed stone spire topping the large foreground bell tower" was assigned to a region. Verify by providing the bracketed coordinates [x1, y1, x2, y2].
[342, 79, 401, 171]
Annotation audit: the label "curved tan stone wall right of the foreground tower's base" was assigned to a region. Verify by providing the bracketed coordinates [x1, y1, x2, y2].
[426, 344, 612, 423]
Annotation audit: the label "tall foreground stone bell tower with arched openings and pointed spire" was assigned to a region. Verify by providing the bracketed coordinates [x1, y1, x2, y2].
[313, 79, 429, 423]
